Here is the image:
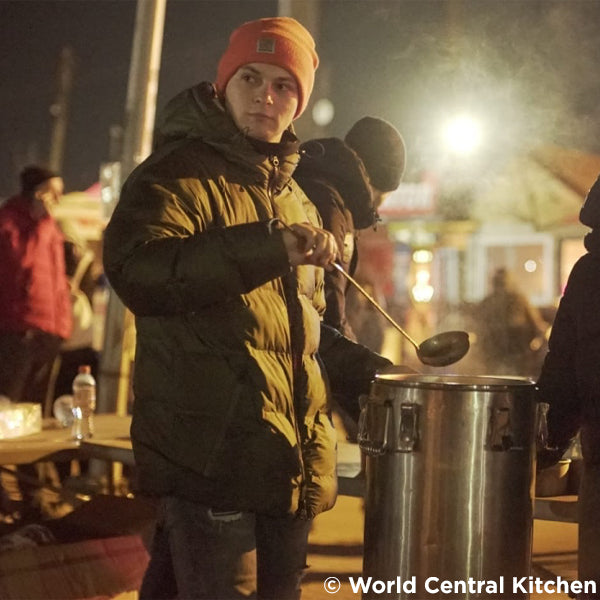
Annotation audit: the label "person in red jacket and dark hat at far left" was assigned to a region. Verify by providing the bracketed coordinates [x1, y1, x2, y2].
[0, 166, 72, 520]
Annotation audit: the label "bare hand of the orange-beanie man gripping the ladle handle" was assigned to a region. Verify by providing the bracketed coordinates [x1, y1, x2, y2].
[282, 223, 338, 269]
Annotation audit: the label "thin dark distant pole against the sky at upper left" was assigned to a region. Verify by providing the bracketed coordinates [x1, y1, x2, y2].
[48, 46, 75, 173]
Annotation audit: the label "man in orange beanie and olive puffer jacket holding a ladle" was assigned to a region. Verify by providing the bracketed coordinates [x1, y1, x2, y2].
[104, 17, 389, 599]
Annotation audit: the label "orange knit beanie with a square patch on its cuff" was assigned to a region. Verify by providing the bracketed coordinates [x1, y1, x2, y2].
[215, 17, 319, 118]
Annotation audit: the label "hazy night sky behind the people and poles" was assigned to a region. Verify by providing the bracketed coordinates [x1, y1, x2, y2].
[0, 0, 600, 197]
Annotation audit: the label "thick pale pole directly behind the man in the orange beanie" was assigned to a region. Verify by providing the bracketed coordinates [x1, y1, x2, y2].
[98, 0, 166, 414]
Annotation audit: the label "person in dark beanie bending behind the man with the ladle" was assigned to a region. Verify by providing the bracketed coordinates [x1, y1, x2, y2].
[294, 117, 405, 340]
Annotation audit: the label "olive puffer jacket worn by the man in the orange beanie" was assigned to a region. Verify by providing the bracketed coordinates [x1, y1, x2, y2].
[104, 84, 336, 516]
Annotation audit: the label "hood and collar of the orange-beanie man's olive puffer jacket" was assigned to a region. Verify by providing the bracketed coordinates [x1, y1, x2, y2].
[153, 81, 300, 187]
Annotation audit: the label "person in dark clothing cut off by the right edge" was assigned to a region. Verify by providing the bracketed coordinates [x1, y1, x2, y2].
[538, 177, 600, 600]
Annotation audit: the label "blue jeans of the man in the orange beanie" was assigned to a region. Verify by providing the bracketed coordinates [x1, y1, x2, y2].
[140, 497, 311, 600]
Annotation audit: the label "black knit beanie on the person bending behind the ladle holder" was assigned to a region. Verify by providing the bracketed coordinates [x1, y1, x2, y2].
[344, 117, 406, 192]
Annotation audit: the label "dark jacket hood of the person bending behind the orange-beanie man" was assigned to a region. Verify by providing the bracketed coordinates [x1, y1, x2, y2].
[294, 138, 378, 229]
